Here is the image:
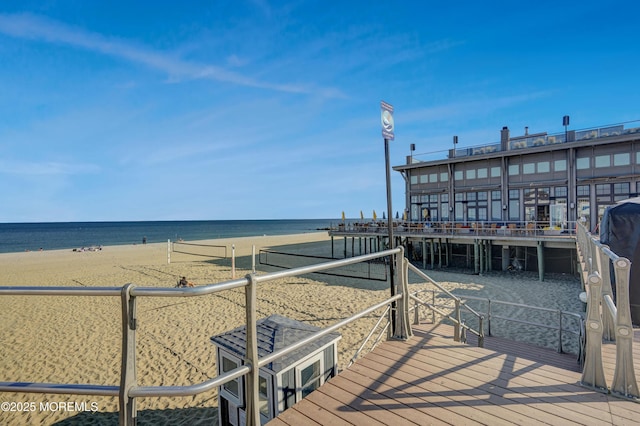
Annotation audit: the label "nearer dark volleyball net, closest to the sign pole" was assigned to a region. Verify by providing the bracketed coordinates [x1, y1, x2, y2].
[258, 249, 388, 281]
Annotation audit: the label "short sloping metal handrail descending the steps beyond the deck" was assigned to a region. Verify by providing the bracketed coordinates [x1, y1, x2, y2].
[409, 264, 484, 348]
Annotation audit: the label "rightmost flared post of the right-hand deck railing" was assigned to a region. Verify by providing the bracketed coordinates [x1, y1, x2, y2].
[611, 257, 640, 400]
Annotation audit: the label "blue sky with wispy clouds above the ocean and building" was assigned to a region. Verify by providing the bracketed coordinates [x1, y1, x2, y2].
[0, 0, 640, 222]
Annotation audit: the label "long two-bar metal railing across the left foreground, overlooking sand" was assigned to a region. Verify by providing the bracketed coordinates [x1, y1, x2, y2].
[0, 247, 412, 426]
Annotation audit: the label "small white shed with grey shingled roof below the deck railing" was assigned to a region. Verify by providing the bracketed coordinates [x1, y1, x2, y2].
[211, 315, 342, 426]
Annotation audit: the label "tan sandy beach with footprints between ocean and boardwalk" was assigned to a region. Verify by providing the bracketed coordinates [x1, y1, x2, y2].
[0, 232, 581, 425]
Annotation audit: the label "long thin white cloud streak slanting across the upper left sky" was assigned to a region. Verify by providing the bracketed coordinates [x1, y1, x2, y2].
[0, 14, 344, 98]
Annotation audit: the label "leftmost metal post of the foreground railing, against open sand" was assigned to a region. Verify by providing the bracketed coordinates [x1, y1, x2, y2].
[118, 284, 137, 426]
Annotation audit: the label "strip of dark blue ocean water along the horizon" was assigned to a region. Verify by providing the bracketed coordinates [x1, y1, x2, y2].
[0, 219, 339, 253]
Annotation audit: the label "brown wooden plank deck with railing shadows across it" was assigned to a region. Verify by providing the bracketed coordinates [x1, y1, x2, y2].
[269, 324, 640, 426]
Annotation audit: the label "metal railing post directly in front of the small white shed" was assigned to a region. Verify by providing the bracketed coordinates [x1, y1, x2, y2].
[244, 274, 260, 426]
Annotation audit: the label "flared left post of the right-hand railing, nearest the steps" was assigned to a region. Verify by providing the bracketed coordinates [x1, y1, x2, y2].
[580, 273, 609, 393]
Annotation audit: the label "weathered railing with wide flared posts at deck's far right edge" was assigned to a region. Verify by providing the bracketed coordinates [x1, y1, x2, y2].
[576, 224, 640, 401]
